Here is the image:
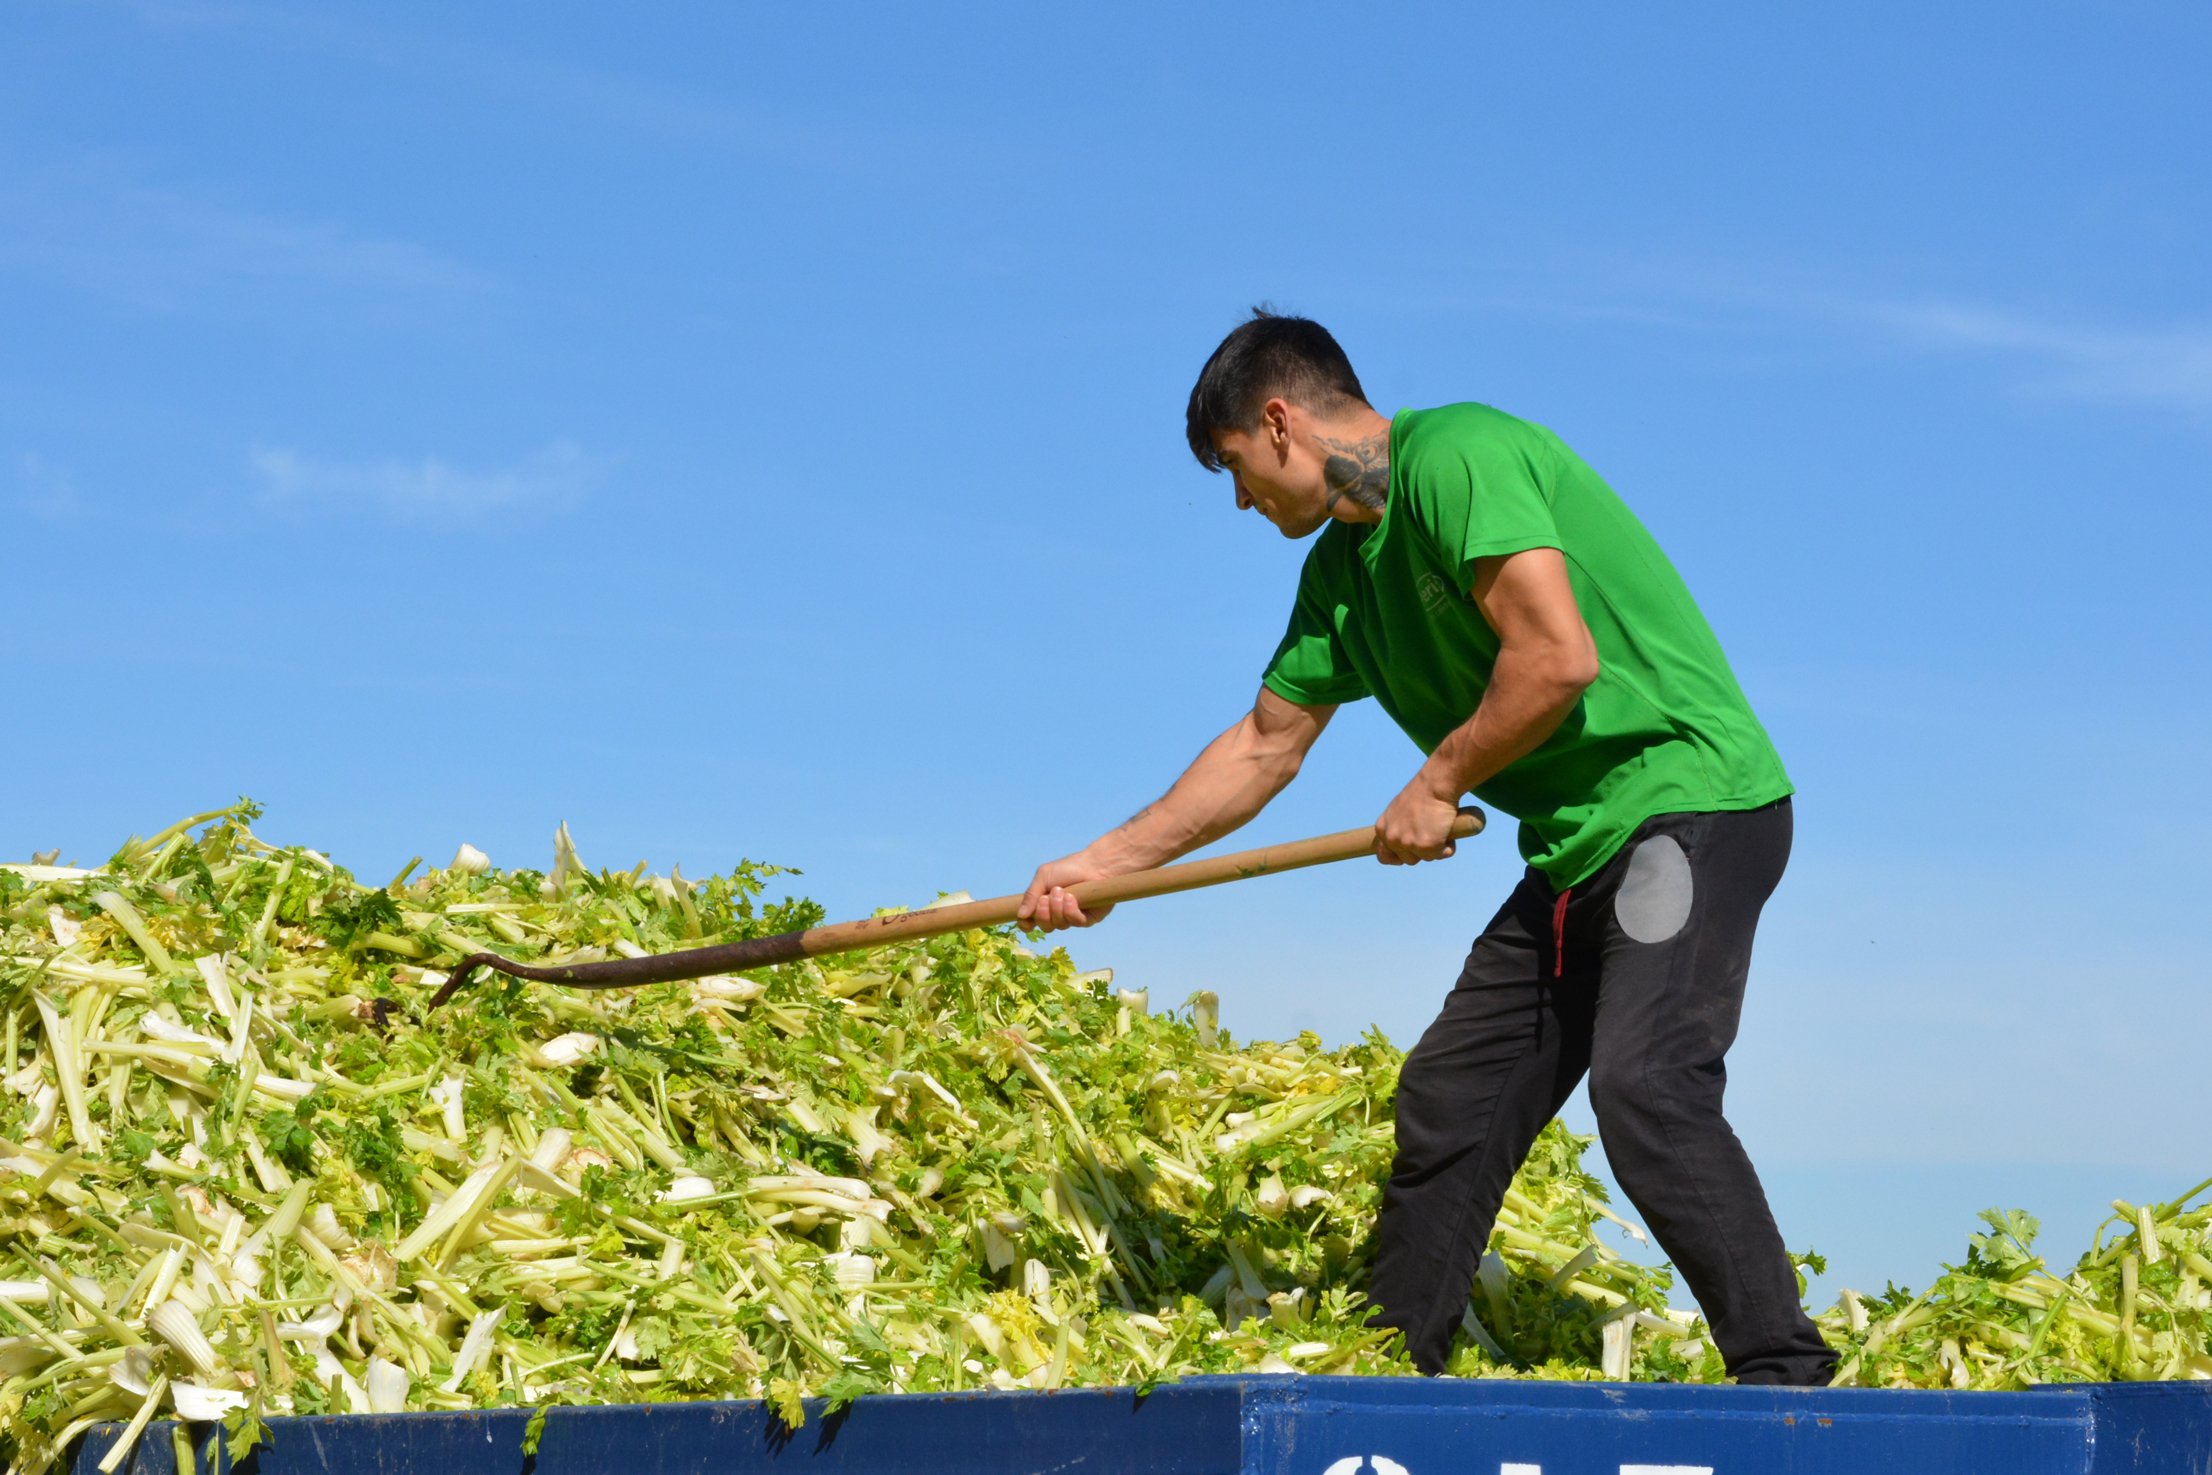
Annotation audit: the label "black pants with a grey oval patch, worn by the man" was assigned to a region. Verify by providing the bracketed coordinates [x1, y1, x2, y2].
[1371, 801, 1836, 1384]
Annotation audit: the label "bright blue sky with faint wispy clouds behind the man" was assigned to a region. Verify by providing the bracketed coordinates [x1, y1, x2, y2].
[0, 0, 2212, 1317]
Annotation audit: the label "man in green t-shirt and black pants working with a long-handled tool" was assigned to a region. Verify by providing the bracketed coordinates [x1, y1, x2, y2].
[1022, 310, 1836, 1384]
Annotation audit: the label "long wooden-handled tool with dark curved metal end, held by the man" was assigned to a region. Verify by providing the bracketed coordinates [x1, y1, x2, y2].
[429, 807, 1482, 1008]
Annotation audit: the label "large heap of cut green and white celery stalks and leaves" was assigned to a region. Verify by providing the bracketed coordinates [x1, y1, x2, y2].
[0, 805, 2212, 1473]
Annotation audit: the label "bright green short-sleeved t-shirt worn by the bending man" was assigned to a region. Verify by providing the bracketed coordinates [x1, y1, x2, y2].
[1265, 405, 1790, 887]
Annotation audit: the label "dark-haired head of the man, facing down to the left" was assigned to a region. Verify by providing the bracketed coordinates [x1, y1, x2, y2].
[1183, 307, 1389, 537]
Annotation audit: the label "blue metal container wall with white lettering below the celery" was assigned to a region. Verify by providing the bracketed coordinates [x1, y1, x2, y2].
[73, 1375, 2212, 1475]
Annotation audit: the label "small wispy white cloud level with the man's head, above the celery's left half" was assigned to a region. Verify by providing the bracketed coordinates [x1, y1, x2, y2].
[248, 440, 593, 522]
